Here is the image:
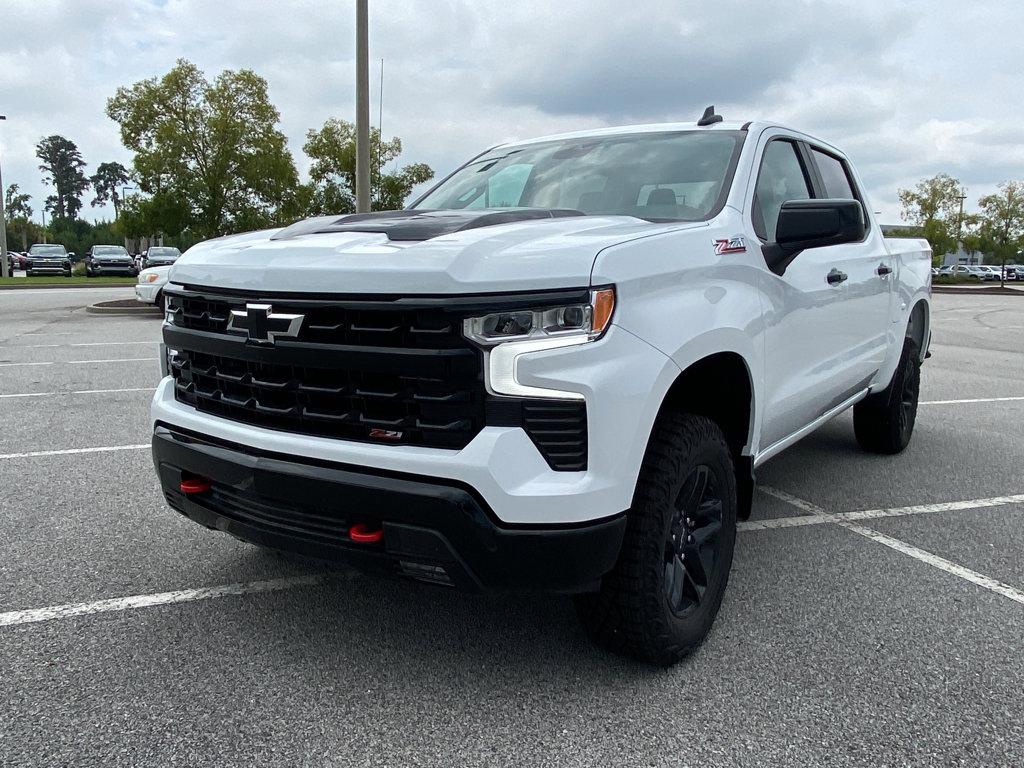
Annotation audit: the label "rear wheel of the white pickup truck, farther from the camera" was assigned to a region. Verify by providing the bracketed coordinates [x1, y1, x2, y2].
[853, 337, 921, 454]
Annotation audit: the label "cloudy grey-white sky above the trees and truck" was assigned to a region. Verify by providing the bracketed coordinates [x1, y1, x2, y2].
[0, 0, 1024, 222]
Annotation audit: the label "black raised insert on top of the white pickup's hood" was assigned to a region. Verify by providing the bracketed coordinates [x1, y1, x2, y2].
[270, 208, 586, 241]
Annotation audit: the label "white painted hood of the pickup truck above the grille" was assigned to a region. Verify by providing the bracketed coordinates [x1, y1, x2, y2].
[170, 212, 707, 294]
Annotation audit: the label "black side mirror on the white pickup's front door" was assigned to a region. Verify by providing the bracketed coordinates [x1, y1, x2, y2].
[764, 199, 866, 274]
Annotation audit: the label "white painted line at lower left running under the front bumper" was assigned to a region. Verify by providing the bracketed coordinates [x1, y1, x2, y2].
[0, 574, 326, 628]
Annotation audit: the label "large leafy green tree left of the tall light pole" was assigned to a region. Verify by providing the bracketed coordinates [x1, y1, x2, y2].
[106, 59, 298, 237]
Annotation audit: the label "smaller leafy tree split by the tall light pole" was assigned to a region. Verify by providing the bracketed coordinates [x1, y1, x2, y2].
[302, 118, 434, 214]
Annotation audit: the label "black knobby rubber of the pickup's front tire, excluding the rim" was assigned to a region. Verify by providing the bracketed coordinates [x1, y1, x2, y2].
[577, 414, 736, 665]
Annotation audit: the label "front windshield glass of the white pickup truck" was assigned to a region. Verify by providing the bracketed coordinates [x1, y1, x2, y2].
[413, 131, 743, 221]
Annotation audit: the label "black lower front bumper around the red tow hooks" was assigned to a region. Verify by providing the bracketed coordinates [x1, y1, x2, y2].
[153, 425, 626, 592]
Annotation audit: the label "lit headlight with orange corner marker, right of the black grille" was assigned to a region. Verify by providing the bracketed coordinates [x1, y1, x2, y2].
[463, 289, 615, 400]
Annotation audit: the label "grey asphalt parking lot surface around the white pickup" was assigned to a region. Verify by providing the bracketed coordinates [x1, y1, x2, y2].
[0, 290, 1024, 765]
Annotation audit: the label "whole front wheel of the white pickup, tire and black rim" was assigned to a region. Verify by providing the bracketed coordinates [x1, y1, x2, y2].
[577, 414, 736, 665]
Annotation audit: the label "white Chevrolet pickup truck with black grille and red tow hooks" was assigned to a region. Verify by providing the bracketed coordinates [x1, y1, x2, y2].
[152, 110, 931, 664]
